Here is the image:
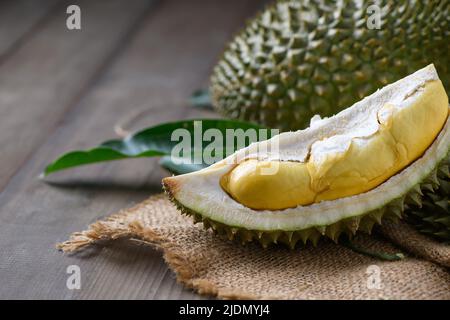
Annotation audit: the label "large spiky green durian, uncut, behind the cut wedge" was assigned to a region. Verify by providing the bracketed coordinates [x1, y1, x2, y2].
[210, 0, 450, 131]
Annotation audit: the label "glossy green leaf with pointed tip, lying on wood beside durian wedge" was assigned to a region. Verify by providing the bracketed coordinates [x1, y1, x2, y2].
[42, 119, 272, 176]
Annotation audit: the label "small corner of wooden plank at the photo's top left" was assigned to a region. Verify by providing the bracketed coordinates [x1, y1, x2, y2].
[0, 0, 57, 63]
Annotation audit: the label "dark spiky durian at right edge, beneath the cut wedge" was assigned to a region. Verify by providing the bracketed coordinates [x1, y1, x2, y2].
[406, 154, 450, 241]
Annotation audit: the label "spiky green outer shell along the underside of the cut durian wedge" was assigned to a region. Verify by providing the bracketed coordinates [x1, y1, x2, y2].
[163, 153, 450, 249]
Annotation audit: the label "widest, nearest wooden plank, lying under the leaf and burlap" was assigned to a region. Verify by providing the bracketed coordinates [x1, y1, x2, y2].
[0, 0, 261, 299]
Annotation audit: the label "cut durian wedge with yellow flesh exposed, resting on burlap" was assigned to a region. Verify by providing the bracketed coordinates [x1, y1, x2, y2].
[163, 65, 450, 247]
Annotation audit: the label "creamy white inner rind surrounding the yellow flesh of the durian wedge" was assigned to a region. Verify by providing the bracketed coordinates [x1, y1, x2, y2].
[163, 66, 450, 241]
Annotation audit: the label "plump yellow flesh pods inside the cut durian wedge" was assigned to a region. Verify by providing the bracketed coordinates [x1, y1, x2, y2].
[220, 80, 448, 210]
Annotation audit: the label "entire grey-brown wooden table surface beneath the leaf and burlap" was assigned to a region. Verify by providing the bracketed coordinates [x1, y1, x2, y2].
[0, 0, 268, 299]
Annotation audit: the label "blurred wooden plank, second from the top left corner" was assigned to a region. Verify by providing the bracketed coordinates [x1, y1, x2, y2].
[0, 0, 156, 191]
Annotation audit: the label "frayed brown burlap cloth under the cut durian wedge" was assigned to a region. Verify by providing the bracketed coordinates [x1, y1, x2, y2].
[58, 194, 450, 299]
